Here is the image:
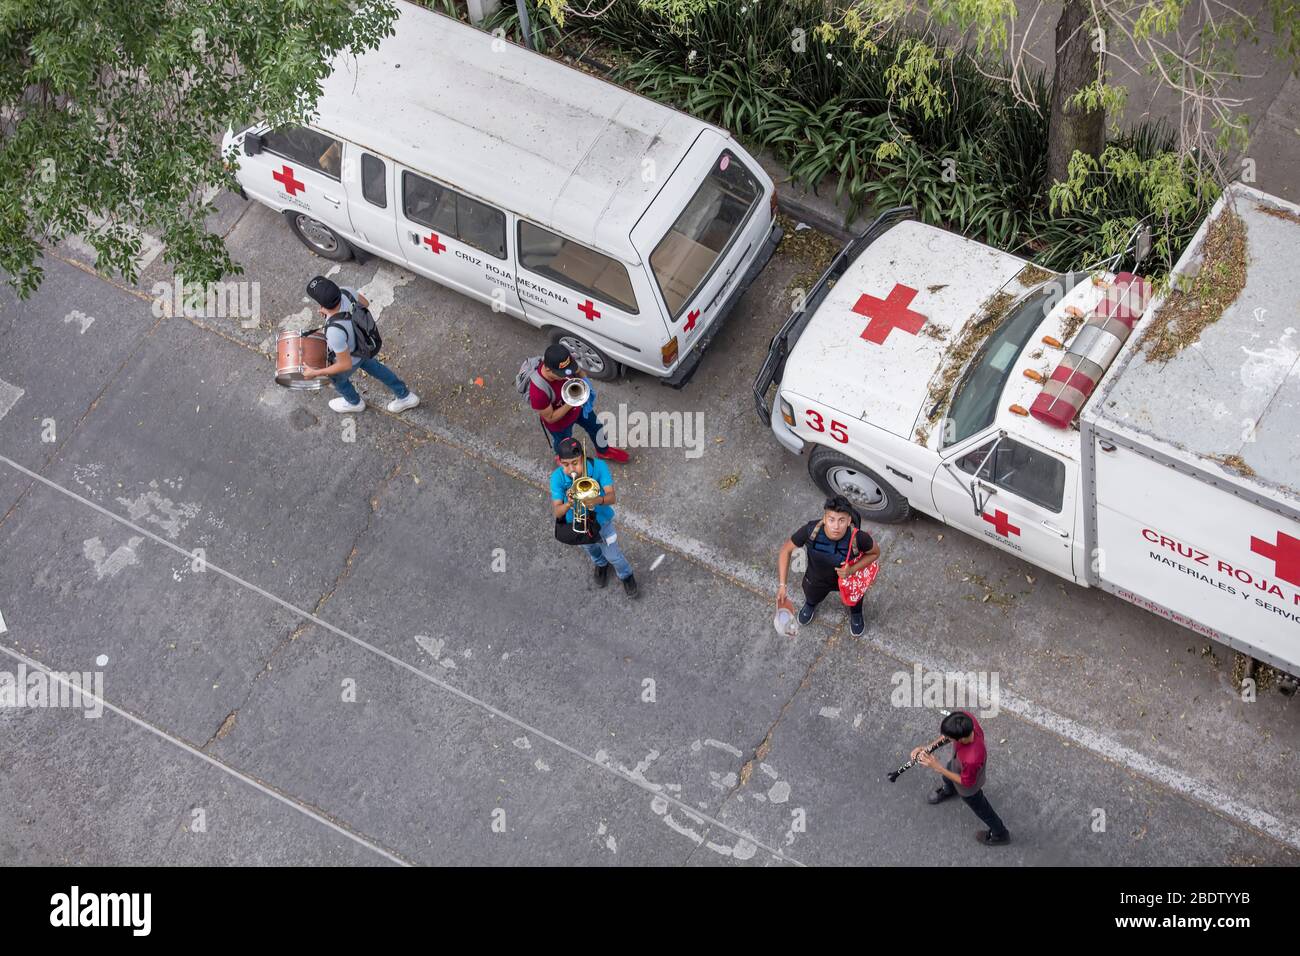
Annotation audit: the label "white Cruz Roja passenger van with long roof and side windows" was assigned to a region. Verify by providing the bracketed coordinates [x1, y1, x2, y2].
[222, 3, 781, 386]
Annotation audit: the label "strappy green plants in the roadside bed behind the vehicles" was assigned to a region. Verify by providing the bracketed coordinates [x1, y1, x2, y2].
[581, 0, 1216, 280]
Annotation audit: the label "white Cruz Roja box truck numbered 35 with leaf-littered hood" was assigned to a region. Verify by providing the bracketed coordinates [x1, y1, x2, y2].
[754, 186, 1300, 675]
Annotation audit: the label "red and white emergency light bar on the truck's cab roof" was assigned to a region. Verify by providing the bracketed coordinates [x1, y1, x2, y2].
[1030, 272, 1151, 428]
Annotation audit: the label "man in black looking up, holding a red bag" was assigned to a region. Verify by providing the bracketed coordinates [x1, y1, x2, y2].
[776, 494, 880, 637]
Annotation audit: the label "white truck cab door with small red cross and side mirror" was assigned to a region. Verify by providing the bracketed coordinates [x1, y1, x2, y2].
[933, 432, 1078, 581]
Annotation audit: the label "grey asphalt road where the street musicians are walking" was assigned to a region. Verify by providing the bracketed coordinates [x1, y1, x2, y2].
[0, 188, 1300, 865]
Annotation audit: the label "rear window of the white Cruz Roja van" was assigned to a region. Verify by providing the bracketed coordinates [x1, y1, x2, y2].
[650, 150, 763, 321]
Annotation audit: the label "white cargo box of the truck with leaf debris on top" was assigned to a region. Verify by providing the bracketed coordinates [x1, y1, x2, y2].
[1080, 186, 1300, 674]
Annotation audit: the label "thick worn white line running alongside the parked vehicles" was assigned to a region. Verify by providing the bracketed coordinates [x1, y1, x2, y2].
[371, 423, 1300, 849]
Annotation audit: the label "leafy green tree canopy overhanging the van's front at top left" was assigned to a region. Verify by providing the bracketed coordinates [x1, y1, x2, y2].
[0, 0, 397, 297]
